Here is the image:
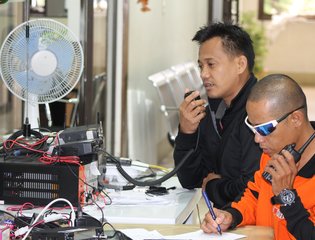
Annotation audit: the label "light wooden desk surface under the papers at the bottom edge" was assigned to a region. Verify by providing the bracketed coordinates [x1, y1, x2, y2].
[114, 224, 274, 240]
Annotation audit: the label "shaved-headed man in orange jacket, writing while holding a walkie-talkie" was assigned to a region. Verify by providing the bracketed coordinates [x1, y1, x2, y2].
[201, 74, 315, 240]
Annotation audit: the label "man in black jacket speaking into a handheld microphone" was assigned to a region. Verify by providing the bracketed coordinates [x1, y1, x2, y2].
[174, 23, 261, 208]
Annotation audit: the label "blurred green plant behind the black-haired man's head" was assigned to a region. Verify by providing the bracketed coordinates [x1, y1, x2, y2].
[241, 12, 267, 76]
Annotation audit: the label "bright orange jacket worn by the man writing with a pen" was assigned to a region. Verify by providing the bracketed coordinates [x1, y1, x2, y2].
[231, 154, 315, 240]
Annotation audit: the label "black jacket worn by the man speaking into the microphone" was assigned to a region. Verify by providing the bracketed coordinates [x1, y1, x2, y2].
[173, 75, 262, 208]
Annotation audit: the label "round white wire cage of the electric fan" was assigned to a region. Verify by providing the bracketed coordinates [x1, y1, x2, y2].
[0, 19, 84, 103]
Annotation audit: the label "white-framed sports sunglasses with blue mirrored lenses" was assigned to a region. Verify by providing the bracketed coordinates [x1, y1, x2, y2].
[245, 105, 305, 137]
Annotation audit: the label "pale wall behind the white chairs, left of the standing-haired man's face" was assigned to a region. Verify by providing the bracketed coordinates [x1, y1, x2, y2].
[128, 0, 208, 163]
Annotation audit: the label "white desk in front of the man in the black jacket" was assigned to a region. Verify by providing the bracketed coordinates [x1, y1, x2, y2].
[83, 177, 201, 224]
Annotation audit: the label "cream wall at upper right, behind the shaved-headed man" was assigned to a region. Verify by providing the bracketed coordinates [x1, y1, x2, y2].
[240, 0, 315, 79]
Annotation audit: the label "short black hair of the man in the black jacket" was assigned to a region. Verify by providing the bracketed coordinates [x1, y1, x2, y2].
[192, 22, 255, 72]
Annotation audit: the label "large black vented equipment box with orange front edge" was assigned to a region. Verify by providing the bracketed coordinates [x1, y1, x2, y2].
[0, 157, 98, 206]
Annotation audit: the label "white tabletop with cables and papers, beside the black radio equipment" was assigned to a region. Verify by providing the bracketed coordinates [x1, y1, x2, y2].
[83, 177, 201, 224]
